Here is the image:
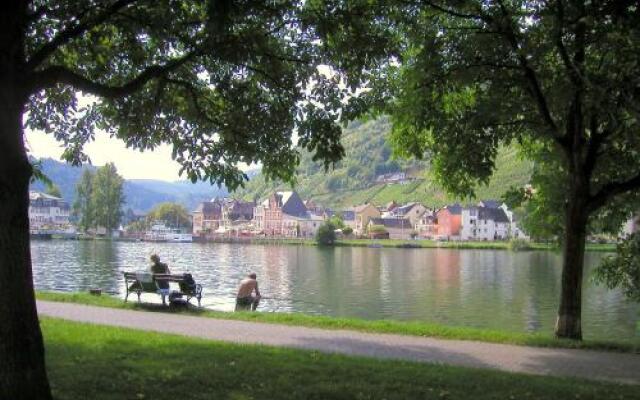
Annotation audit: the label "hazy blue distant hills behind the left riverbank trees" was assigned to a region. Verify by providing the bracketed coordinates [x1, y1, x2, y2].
[31, 158, 228, 212]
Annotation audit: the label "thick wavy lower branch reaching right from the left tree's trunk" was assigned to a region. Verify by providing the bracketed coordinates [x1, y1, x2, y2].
[31, 50, 198, 99]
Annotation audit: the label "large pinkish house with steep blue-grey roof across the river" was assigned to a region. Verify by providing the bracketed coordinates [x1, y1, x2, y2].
[253, 192, 310, 237]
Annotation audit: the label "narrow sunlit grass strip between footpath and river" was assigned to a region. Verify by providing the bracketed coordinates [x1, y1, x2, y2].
[36, 292, 640, 352]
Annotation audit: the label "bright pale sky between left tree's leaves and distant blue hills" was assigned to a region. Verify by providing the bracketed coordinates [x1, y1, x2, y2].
[25, 130, 186, 181]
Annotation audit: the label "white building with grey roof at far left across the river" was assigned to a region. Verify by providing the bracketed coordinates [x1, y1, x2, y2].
[29, 191, 71, 230]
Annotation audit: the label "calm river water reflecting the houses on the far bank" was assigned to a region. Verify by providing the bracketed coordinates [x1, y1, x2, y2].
[31, 240, 640, 341]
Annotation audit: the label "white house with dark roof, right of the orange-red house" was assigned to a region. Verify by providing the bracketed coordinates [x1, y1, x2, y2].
[460, 206, 511, 240]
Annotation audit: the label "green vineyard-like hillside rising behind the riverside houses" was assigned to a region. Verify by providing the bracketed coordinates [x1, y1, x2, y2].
[239, 119, 532, 208]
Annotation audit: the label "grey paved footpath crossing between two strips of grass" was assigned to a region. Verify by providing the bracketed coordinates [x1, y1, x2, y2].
[38, 301, 640, 385]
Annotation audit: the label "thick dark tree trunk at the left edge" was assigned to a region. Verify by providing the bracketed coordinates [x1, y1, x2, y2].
[0, 79, 51, 400]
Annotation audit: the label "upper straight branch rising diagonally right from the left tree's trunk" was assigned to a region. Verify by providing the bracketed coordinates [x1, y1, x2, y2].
[26, 0, 138, 70]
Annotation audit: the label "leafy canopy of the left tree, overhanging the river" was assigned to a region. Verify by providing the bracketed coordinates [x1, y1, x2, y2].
[24, 0, 356, 188]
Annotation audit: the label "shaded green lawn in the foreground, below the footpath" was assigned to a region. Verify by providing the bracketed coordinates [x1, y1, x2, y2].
[41, 318, 638, 400]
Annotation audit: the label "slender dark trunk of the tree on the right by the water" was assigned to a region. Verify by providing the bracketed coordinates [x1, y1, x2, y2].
[555, 173, 589, 340]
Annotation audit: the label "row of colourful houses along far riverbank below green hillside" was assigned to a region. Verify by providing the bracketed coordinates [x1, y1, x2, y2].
[193, 191, 527, 240]
